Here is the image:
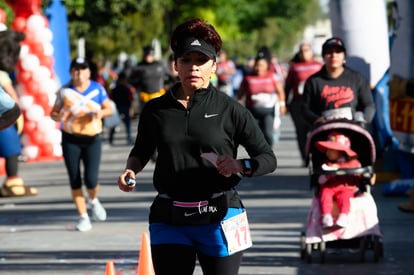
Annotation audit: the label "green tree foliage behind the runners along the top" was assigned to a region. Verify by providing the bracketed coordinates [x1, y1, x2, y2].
[39, 0, 322, 61]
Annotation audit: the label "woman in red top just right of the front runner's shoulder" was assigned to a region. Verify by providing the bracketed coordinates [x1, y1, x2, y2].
[237, 53, 286, 145]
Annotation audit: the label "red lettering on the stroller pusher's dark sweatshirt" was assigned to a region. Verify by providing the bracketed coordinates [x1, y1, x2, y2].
[321, 85, 354, 108]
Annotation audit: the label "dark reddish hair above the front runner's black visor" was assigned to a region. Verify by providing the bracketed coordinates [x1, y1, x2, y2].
[170, 19, 223, 59]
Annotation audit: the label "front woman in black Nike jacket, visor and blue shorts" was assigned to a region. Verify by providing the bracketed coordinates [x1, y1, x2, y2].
[118, 19, 276, 275]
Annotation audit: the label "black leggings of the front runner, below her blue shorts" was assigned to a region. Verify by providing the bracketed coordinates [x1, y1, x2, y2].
[151, 244, 243, 275]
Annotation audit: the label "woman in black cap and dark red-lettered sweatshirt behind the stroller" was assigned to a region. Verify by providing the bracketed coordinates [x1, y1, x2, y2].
[301, 37, 375, 126]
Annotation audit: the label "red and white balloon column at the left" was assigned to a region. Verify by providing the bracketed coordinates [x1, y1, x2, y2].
[2, 0, 62, 161]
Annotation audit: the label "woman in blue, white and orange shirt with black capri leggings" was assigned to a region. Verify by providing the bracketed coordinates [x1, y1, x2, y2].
[51, 57, 112, 231]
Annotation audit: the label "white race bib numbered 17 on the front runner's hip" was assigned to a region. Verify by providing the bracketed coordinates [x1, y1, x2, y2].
[221, 211, 252, 254]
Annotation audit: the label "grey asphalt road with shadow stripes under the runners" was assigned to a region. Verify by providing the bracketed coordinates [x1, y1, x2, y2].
[0, 116, 414, 275]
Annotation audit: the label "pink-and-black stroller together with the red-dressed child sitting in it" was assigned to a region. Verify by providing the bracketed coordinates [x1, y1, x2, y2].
[301, 119, 383, 263]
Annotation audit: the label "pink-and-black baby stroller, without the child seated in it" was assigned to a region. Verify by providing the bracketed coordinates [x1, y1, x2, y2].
[301, 119, 383, 263]
